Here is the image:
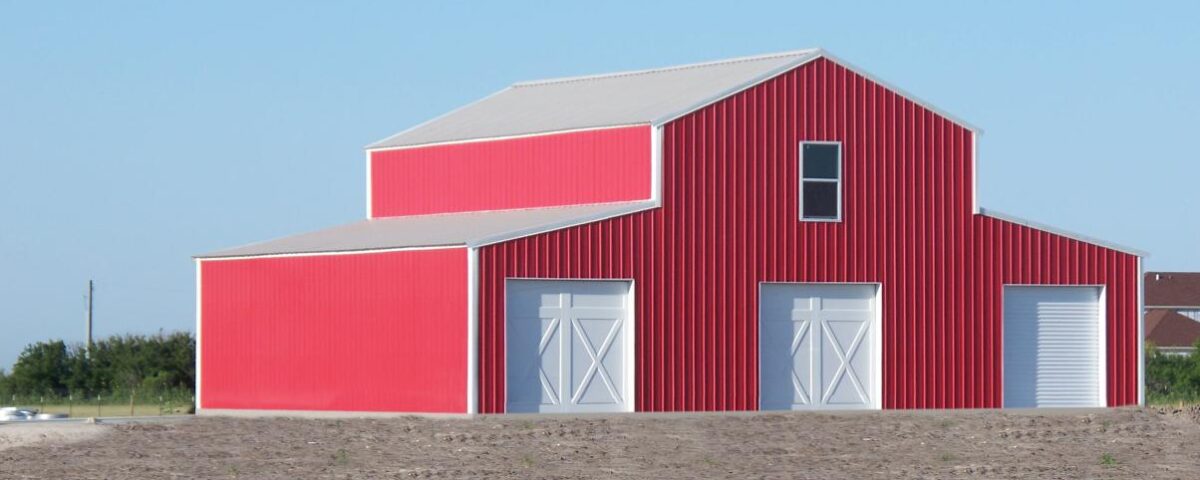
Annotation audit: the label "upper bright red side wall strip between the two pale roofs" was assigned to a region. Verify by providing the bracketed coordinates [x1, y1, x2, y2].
[371, 125, 650, 217]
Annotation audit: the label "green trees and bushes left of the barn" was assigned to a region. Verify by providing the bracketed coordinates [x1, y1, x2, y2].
[0, 332, 196, 404]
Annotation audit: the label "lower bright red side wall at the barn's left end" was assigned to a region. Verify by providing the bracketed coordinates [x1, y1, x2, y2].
[200, 248, 467, 413]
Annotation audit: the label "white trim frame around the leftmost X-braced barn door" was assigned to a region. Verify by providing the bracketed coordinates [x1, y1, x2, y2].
[499, 277, 637, 415]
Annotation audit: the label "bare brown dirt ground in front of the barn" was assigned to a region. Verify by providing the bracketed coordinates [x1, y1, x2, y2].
[0, 408, 1200, 480]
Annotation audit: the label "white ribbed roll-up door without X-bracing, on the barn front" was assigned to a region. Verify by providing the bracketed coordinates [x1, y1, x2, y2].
[1004, 287, 1104, 408]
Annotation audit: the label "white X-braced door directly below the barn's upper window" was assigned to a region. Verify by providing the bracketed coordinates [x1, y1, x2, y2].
[758, 283, 880, 410]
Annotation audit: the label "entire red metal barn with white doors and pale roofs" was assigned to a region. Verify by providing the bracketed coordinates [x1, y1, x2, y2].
[197, 50, 1142, 413]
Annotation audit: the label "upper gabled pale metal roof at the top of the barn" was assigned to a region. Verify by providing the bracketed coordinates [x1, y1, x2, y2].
[367, 48, 977, 149]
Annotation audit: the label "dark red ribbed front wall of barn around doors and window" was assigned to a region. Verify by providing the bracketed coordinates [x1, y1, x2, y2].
[480, 59, 1138, 413]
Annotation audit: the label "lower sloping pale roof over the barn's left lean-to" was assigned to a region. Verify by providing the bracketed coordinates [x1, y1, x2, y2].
[196, 200, 658, 258]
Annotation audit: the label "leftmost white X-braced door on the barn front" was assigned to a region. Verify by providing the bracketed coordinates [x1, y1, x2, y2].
[505, 280, 634, 413]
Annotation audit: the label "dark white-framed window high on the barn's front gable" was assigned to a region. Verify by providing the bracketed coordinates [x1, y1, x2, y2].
[800, 143, 841, 220]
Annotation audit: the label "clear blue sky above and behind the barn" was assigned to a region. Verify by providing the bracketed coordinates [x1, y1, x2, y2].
[0, 0, 1200, 367]
